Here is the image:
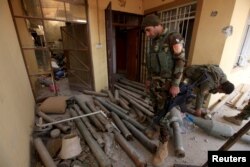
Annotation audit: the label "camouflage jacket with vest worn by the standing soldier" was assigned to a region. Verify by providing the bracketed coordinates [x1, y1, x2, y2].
[147, 29, 185, 86]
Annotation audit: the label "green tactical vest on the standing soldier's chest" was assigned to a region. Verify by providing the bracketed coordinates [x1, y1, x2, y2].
[147, 33, 174, 79]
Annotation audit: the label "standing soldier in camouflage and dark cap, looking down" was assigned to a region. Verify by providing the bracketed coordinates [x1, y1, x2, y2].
[142, 14, 185, 165]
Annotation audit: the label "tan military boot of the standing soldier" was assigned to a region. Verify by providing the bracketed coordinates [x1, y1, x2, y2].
[152, 141, 168, 166]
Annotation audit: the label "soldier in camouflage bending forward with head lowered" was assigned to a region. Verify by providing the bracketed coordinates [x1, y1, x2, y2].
[184, 64, 234, 117]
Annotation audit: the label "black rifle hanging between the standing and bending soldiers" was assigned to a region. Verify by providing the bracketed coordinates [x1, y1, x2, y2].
[152, 72, 208, 124]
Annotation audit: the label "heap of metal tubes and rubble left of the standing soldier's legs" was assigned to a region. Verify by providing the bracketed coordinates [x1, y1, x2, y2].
[33, 79, 159, 167]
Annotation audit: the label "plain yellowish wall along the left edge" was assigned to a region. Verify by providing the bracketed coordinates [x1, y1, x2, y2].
[0, 0, 34, 167]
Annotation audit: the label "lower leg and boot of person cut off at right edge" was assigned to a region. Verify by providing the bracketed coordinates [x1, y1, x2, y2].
[223, 100, 250, 125]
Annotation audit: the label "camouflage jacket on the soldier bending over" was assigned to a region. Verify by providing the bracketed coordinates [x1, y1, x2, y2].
[184, 64, 227, 109]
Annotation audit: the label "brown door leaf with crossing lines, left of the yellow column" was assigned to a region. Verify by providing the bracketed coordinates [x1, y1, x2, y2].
[61, 23, 93, 91]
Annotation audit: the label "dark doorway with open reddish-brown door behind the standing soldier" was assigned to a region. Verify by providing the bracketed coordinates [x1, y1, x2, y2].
[105, 3, 142, 89]
